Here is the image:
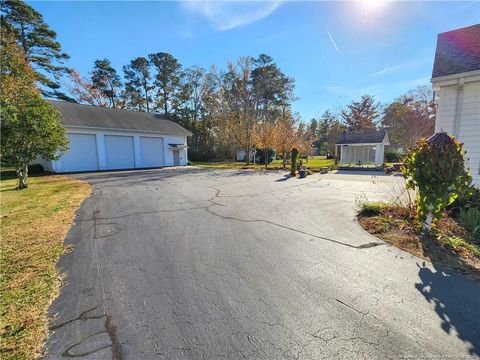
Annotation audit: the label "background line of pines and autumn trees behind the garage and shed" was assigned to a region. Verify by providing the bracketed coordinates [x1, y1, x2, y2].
[2, 0, 435, 167]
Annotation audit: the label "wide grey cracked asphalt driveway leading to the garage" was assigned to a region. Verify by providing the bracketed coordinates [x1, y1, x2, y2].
[46, 168, 480, 359]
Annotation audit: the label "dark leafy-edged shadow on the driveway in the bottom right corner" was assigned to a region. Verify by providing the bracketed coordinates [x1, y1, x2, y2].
[415, 262, 480, 356]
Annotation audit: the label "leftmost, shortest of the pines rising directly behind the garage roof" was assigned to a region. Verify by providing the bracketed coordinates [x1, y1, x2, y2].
[92, 59, 122, 108]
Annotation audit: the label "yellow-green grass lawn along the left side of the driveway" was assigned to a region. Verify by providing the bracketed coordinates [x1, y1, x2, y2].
[0, 170, 90, 360]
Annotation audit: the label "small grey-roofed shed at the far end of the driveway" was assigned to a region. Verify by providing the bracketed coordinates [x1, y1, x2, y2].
[335, 130, 390, 165]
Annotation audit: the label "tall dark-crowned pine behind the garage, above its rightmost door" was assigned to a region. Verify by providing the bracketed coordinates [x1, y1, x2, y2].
[148, 52, 183, 117]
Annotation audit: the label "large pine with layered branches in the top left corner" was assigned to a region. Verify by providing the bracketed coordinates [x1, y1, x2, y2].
[1, 0, 71, 100]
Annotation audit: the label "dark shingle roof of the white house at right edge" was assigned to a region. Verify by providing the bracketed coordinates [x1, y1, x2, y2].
[432, 24, 480, 78]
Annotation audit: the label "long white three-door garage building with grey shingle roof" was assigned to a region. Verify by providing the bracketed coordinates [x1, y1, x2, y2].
[36, 101, 191, 172]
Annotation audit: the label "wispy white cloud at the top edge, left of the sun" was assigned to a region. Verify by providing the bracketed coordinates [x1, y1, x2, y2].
[181, 0, 281, 31]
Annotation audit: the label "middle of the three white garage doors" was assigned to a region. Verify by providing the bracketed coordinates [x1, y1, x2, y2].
[105, 135, 135, 169]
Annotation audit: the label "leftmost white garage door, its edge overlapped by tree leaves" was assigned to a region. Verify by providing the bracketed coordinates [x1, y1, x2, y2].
[61, 134, 98, 172]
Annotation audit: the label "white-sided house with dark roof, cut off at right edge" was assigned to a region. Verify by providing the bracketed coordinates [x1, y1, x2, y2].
[431, 24, 480, 186]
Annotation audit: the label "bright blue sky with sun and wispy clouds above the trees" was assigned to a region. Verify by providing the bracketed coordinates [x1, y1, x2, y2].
[30, 0, 480, 120]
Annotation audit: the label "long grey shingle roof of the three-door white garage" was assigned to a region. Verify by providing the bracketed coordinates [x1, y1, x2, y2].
[49, 100, 192, 136]
